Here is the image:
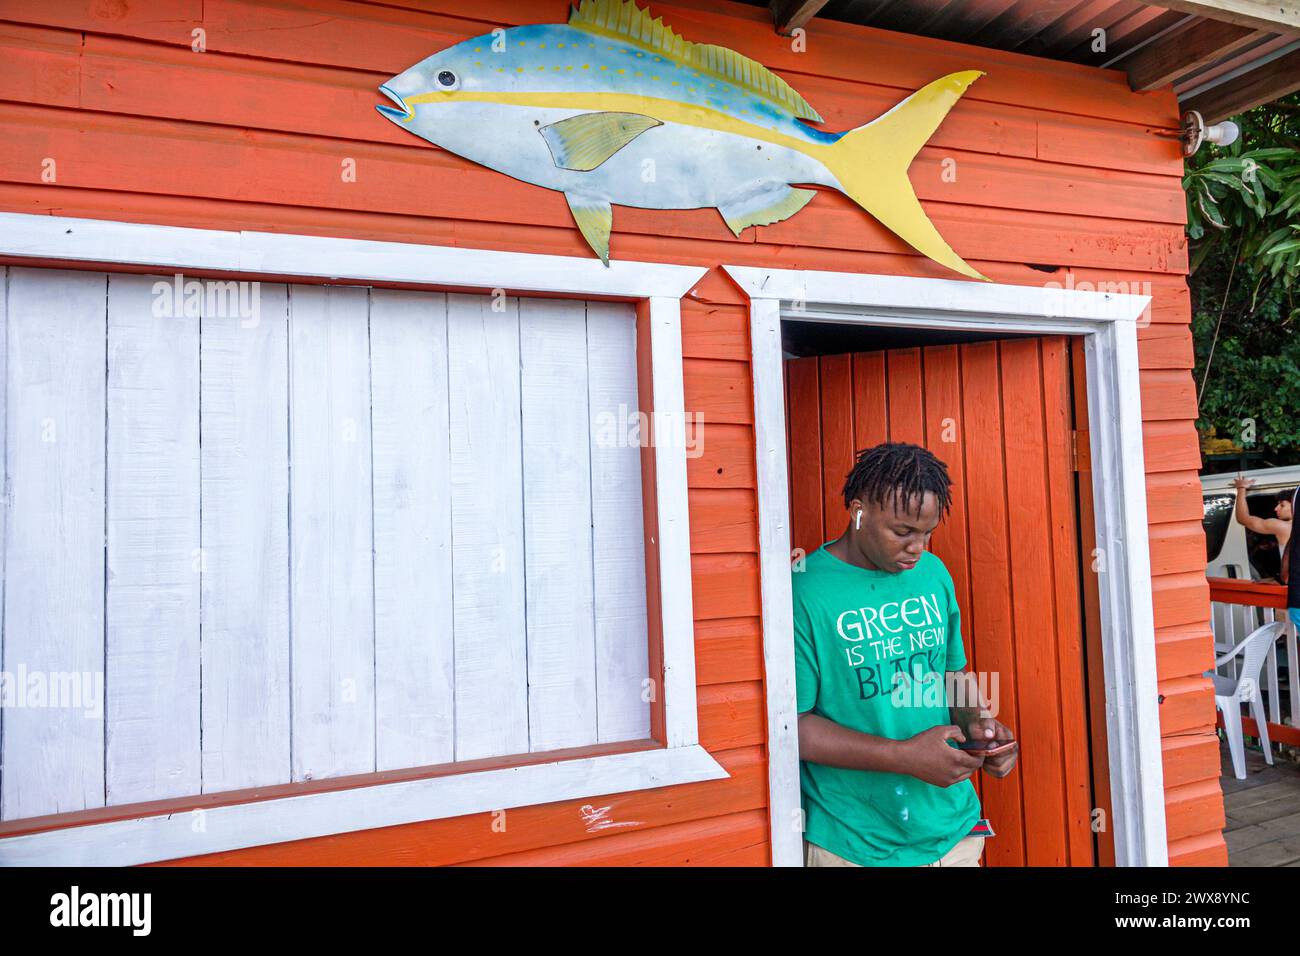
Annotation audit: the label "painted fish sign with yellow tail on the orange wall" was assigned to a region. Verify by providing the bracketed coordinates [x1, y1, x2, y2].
[377, 0, 984, 278]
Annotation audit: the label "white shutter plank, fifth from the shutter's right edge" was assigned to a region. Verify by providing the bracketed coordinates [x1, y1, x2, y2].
[289, 286, 374, 780]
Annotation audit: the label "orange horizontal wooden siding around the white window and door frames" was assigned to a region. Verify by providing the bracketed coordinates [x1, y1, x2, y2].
[0, 0, 1226, 864]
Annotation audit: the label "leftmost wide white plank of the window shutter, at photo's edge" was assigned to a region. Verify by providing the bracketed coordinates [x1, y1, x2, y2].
[0, 268, 107, 819]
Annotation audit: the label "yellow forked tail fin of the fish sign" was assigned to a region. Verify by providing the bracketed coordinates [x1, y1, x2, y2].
[827, 70, 988, 281]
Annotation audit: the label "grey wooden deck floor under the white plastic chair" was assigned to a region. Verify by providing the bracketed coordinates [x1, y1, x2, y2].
[1219, 743, 1300, 866]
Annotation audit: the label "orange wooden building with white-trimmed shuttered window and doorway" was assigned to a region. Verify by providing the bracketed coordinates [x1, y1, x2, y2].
[0, 0, 1263, 866]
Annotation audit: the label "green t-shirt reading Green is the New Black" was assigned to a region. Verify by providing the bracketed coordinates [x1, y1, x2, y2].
[793, 545, 979, 866]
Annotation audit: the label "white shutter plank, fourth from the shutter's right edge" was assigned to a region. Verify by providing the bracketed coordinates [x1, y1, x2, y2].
[371, 289, 455, 770]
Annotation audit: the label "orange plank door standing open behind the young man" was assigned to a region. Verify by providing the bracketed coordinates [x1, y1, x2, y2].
[785, 337, 1105, 866]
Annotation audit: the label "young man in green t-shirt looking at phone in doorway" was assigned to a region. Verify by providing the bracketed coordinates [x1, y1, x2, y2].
[793, 444, 1018, 866]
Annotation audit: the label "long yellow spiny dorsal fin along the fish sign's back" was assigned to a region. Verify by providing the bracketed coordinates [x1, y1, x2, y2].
[569, 0, 822, 122]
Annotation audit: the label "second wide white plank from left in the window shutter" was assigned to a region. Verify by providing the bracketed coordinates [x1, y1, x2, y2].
[105, 274, 200, 805]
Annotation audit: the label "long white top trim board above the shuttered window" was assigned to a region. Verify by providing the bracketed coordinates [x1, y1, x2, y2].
[0, 212, 707, 299]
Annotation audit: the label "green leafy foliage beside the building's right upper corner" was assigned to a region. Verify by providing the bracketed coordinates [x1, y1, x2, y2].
[1183, 94, 1300, 464]
